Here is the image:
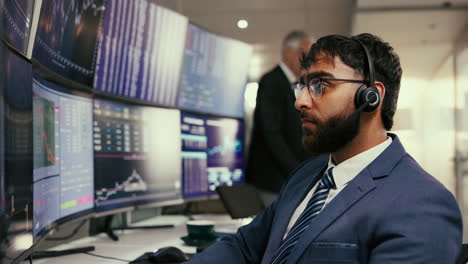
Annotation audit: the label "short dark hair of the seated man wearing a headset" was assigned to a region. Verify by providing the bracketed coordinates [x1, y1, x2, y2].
[301, 33, 402, 130]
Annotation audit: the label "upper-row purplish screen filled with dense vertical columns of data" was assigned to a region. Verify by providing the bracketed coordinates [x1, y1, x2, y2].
[94, 0, 188, 106]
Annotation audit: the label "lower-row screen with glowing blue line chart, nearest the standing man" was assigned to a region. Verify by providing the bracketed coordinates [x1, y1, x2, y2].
[181, 113, 244, 198]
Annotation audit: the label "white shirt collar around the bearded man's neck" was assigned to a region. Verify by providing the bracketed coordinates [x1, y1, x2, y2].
[327, 137, 392, 189]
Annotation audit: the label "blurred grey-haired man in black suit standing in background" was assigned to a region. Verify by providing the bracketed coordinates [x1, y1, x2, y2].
[246, 31, 310, 205]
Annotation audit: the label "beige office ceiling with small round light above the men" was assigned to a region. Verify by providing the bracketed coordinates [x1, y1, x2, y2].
[154, 0, 468, 81]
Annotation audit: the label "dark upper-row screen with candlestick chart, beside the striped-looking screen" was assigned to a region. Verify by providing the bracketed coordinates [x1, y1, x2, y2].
[33, 0, 106, 86]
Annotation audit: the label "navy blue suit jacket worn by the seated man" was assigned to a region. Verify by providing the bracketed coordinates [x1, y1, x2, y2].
[190, 134, 462, 264]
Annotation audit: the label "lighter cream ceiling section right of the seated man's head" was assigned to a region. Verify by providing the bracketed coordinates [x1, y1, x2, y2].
[351, 0, 468, 80]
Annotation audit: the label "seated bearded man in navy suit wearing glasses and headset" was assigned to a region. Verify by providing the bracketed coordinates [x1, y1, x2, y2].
[190, 34, 462, 264]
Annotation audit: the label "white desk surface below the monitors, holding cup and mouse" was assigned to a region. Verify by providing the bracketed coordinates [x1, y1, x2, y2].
[23, 215, 246, 264]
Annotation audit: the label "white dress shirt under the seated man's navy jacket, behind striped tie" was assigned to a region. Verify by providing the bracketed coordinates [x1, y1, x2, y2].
[283, 137, 392, 238]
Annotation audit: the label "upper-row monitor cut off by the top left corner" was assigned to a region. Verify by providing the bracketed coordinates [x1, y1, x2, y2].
[0, 0, 41, 58]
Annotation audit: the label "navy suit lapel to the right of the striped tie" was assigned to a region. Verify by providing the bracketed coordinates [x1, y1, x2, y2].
[288, 169, 375, 263]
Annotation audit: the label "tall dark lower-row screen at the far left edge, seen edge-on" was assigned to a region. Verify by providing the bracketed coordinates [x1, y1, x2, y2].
[0, 41, 33, 263]
